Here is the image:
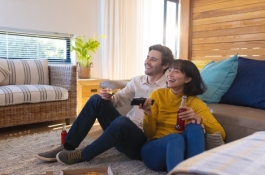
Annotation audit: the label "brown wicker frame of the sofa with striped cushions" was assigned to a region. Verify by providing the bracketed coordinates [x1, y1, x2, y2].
[0, 65, 77, 128]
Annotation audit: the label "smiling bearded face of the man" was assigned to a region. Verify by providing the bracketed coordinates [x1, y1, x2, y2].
[144, 50, 167, 76]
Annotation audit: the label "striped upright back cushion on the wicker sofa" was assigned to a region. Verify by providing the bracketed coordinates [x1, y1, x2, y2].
[0, 59, 49, 85]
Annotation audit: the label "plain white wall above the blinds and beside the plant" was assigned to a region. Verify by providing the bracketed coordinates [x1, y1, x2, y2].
[0, 0, 102, 78]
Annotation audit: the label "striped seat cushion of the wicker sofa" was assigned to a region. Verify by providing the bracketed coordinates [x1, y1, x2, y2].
[0, 85, 68, 106]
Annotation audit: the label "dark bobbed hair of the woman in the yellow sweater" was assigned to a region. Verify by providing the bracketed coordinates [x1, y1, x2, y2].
[168, 59, 207, 96]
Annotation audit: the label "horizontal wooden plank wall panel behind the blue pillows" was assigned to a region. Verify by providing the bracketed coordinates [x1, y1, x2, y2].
[189, 0, 265, 61]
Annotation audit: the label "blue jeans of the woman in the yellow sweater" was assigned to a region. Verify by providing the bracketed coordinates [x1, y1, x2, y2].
[141, 124, 205, 172]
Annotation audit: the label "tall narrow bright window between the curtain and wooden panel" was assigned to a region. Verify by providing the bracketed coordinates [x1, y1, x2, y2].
[163, 0, 179, 58]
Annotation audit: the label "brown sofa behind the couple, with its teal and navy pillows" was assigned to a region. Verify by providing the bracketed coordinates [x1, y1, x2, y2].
[100, 54, 265, 143]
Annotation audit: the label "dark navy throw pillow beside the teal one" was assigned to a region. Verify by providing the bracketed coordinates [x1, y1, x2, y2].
[220, 57, 265, 109]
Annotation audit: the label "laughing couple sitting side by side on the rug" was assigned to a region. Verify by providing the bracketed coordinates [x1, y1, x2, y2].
[37, 45, 225, 172]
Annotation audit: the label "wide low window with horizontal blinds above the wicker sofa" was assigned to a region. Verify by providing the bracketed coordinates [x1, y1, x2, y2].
[0, 30, 71, 63]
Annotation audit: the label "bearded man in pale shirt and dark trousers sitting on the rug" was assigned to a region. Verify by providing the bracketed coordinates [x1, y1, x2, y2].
[37, 45, 173, 165]
